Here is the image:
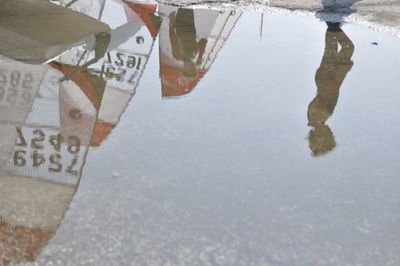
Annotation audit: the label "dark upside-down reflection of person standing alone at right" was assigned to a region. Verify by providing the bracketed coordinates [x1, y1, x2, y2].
[307, 22, 354, 156]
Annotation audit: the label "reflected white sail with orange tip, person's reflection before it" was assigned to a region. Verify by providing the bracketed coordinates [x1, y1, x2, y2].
[159, 5, 241, 98]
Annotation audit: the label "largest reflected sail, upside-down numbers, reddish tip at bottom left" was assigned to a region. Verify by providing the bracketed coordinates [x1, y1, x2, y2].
[0, 58, 91, 263]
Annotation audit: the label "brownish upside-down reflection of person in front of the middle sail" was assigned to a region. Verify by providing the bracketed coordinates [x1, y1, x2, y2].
[169, 8, 207, 80]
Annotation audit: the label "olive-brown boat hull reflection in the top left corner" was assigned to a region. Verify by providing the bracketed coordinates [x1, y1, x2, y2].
[0, 0, 110, 64]
